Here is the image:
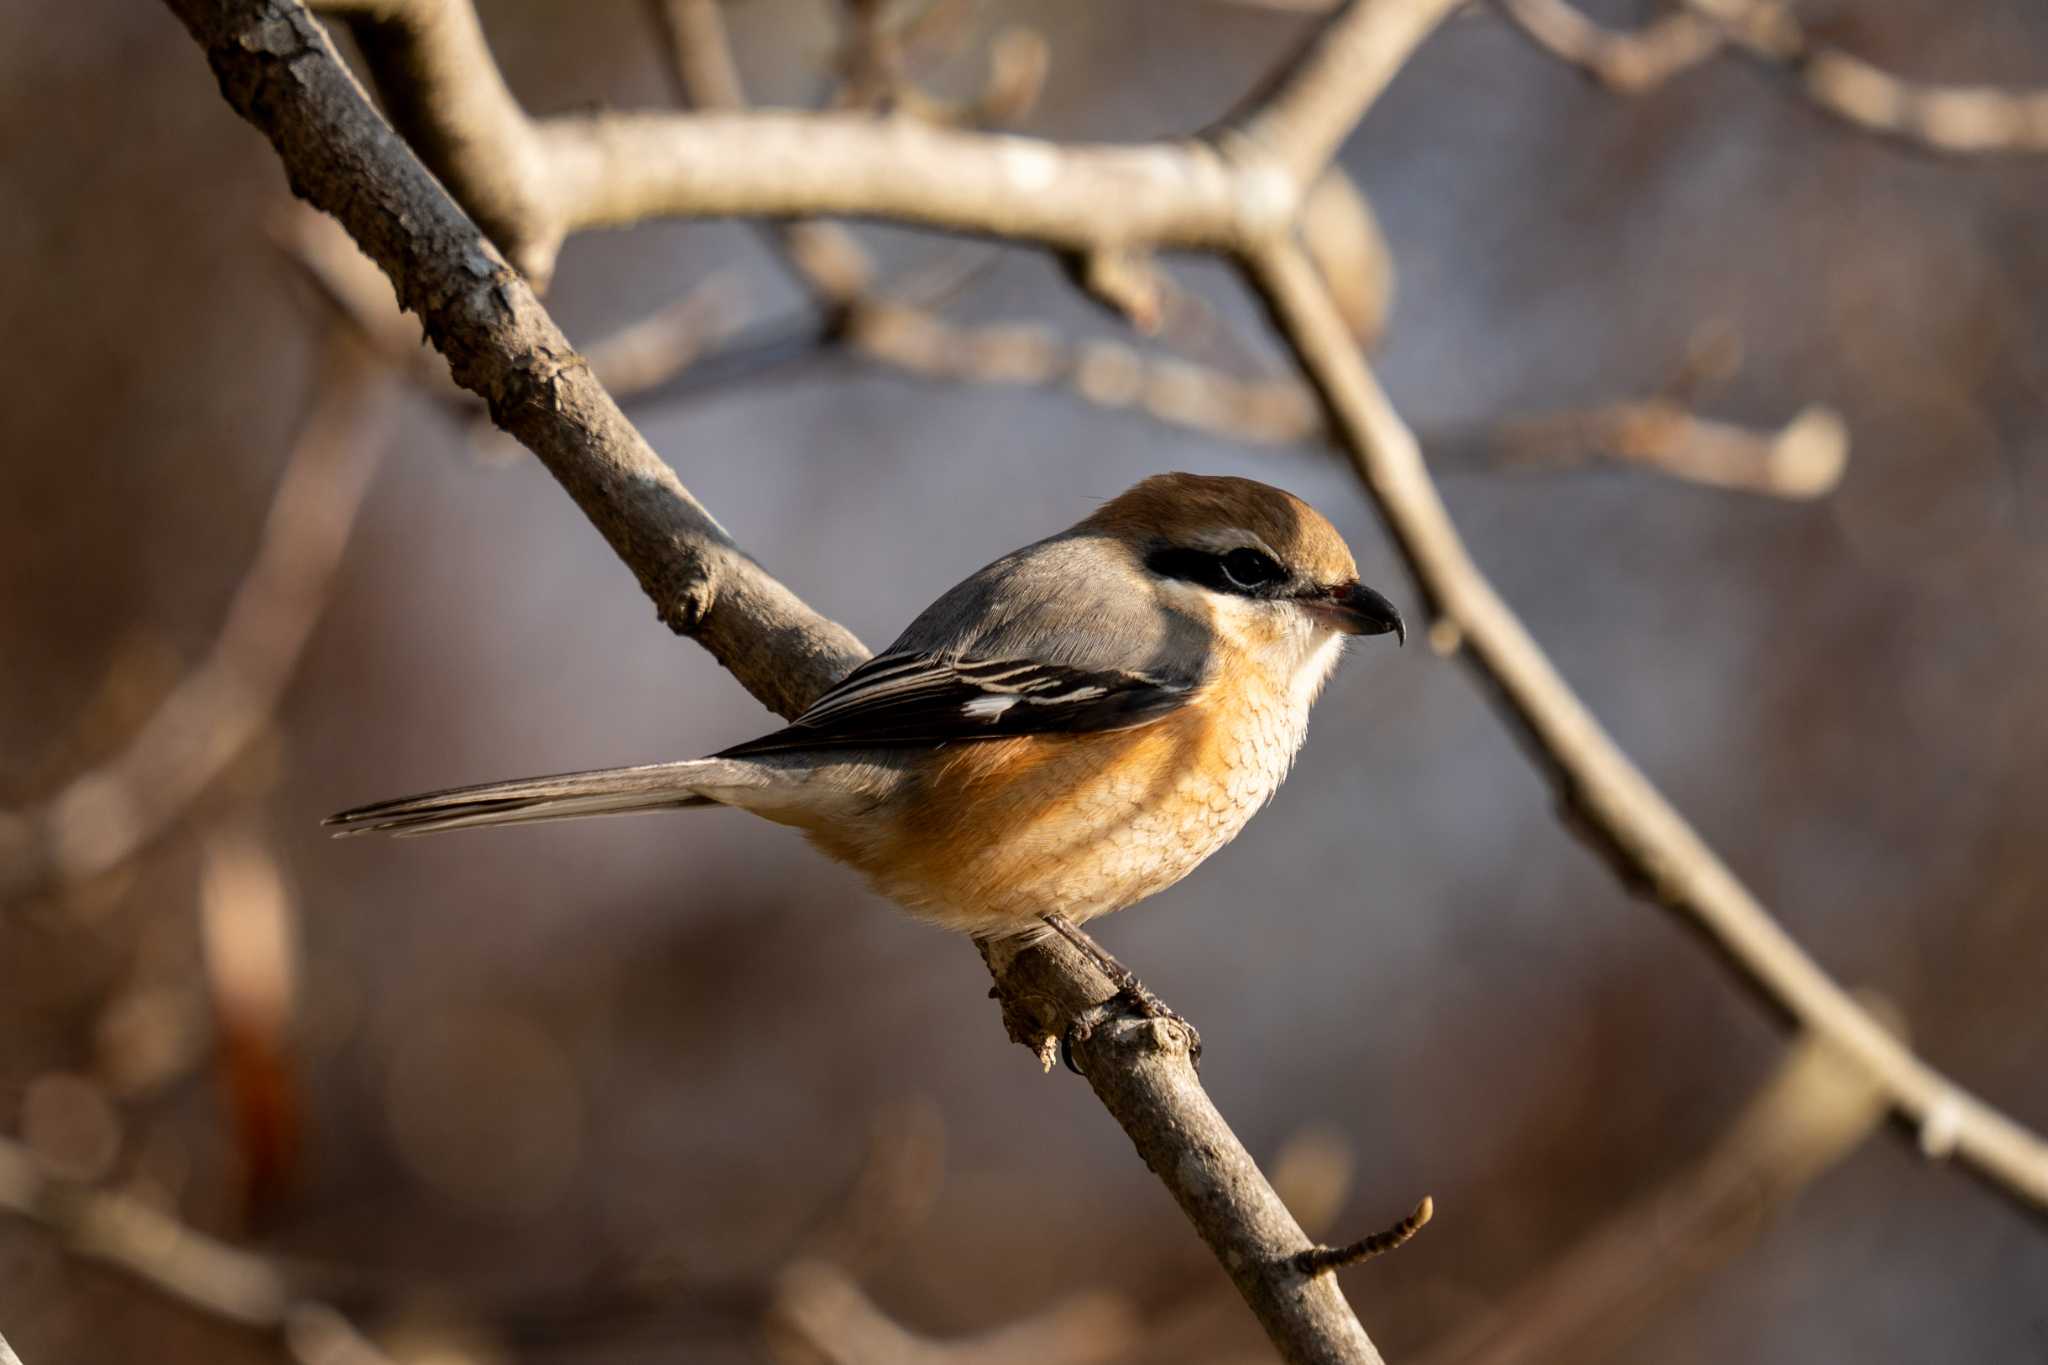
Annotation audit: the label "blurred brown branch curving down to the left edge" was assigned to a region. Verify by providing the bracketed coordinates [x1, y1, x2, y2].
[0, 327, 393, 908]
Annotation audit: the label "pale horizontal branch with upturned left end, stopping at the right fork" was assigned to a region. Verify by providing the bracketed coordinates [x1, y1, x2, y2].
[317, 0, 1261, 258]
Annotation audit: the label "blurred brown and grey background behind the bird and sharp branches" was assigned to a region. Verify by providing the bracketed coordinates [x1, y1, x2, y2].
[0, 0, 2048, 1365]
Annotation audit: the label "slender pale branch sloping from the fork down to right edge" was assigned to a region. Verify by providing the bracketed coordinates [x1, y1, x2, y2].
[1247, 235, 2048, 1205]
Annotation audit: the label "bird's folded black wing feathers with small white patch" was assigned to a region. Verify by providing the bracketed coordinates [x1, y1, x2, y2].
[715, 655, 1194, 759]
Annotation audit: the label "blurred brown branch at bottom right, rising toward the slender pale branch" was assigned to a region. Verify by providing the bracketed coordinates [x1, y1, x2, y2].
[1419, 1001, 1896, 1365]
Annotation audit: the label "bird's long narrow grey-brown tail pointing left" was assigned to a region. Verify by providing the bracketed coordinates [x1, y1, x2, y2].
[326, 759, 762, 837]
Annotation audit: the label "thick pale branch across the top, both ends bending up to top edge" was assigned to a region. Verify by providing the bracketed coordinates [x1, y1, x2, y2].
[307, 0, 1456, 282]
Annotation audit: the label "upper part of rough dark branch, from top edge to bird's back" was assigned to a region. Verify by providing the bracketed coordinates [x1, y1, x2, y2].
[172, 0, 866, 716]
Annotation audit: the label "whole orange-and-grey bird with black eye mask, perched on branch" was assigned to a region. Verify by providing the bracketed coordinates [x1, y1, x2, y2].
[328, 475, 1407, 1055]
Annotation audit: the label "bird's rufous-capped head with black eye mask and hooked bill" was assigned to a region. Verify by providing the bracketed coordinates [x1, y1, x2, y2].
[1081, 475, 1407, 688]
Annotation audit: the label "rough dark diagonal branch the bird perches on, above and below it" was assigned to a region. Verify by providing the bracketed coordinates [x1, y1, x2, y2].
[170, 0, 1409, 1363]
